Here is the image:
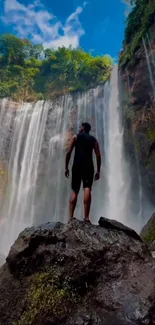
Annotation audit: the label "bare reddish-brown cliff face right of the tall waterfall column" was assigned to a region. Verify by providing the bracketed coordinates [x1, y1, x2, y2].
[120, 24, 155, 204]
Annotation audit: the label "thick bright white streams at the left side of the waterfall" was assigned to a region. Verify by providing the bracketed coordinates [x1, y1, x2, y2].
[1, 102, 48, 251]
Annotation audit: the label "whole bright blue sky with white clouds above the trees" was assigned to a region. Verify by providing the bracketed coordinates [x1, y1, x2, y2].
[0, 0, 130, 58]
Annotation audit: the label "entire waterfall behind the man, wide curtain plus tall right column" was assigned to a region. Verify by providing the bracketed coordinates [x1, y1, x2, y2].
[0, 66, 134, 254]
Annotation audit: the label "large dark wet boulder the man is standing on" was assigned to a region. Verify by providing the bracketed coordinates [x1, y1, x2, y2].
[0, 218, 155, 325]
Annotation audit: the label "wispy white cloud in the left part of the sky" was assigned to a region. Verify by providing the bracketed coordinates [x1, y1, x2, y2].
[1, 0, 87, 48]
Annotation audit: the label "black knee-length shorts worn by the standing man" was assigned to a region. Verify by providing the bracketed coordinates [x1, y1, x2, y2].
[72, 166, 94, 194]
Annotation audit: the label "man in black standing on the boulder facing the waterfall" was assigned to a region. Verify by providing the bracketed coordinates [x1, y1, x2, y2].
[65, 123, 101, 223]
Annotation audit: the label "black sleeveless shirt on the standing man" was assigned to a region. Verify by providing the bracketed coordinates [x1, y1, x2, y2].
[73, 132, 96, 169]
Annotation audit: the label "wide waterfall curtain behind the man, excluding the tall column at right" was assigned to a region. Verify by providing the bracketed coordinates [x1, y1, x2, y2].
[0, 86, 106, 254]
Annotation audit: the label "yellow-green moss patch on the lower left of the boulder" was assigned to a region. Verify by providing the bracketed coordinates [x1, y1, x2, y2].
[14, 273, 78, 325]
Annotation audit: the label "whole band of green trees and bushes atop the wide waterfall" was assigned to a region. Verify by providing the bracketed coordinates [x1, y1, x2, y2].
[0, 34, 113, 100]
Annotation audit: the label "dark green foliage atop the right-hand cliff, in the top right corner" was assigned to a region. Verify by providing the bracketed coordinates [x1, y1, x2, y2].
[120, 0, 155, 65]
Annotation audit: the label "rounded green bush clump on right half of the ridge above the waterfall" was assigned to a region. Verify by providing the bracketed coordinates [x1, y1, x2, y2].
[36, 47, 113, 96]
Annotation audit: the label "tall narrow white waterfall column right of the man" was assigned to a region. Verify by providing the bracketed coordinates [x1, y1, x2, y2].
[107, 66, 130, 224]
